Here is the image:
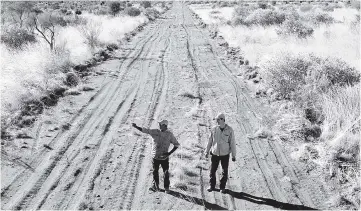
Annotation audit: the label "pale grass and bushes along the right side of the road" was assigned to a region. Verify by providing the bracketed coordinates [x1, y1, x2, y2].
[191, 3, 361, 209]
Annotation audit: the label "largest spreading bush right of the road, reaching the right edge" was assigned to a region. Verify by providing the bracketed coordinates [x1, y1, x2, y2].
[261, 54, 360, 100]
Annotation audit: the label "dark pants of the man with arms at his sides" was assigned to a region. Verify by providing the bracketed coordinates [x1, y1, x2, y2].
[209, 154, 229, 189]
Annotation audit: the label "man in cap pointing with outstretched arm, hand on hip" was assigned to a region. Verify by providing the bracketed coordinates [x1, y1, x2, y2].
[132, 120, 179, 193]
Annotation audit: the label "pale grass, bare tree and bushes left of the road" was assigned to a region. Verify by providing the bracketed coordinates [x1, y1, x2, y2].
[0, 2, 169, 139]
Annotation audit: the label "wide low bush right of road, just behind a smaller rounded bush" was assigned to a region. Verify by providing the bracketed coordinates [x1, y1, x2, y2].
[245, 9, 286, 26]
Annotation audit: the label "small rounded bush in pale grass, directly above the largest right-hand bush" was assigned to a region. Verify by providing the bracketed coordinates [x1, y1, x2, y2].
[277, 18, 314, 38]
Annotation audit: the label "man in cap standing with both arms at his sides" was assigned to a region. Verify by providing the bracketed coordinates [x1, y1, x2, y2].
[204, 113, 236, 193]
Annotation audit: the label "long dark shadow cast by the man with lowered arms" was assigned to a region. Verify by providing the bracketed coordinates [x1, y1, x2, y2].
[227, 189, 316, 210]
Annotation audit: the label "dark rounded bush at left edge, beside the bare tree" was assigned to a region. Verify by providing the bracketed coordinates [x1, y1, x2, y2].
[1, 28, 36, 49]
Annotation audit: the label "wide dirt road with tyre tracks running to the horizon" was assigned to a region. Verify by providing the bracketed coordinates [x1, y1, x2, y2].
[1, 2, 327, 209]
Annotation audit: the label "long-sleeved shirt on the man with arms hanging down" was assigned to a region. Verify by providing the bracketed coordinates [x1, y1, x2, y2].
[206, 124, 236, 157]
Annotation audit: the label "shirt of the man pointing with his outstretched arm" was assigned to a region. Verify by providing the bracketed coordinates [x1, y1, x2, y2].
[142, 128, 179, 160]
